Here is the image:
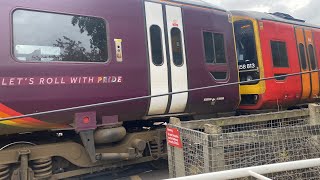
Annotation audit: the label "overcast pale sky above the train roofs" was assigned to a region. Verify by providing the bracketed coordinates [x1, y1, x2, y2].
[203, 0, 320, 25]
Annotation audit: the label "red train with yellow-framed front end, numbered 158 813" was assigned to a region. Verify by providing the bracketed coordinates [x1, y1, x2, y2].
[232, 11, 319, 110]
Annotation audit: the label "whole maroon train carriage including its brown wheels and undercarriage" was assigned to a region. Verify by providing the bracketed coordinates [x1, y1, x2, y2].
[0, 0, 239, 179]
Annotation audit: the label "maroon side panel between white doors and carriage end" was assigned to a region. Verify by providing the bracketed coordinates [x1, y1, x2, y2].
[183, 7, 239, 113]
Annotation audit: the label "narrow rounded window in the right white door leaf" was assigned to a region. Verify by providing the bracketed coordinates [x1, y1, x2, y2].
[171, 28, 183, 66]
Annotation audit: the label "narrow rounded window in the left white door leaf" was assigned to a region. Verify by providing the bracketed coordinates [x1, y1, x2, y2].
[150, 25, 163, 66]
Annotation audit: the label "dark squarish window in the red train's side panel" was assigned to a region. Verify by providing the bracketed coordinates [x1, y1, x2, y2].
[271, 41, 289, 67]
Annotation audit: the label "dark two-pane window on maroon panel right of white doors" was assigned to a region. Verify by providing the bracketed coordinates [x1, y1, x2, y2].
[203, 32, 226, 64]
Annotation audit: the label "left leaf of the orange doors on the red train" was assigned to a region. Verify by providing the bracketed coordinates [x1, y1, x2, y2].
[295, 27, 312, 101]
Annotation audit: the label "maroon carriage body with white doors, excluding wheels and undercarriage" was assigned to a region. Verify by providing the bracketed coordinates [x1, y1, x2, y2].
[0, 0, 239, 134]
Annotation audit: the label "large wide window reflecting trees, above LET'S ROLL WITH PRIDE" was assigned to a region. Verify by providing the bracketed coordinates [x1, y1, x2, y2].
[13, 10, 108, 62]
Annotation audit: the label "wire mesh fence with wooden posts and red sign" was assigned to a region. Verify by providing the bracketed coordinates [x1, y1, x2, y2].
[167, 104, 320, 179]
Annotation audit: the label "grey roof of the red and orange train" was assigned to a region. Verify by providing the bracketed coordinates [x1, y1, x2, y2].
[231, 11, 320, 29]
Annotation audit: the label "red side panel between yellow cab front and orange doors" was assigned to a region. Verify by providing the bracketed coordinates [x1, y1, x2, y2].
[259, 21, 302, 108]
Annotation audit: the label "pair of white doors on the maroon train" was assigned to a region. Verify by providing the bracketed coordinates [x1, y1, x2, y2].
[144, 1, 188, 116]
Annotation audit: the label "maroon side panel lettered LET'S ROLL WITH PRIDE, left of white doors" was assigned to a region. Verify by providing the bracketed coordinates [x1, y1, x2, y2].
[0, 0, 149, 133]
